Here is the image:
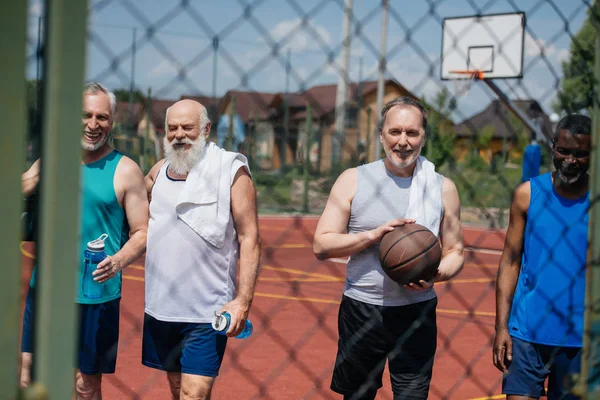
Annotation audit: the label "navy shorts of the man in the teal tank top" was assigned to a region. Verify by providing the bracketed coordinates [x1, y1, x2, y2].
[21, 287, 121, 375]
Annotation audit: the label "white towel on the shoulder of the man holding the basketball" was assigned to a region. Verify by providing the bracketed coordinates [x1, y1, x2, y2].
[406, 156, 444, 236]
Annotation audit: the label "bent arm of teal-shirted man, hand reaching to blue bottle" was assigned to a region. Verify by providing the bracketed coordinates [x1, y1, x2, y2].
[92, 157, 148, 283]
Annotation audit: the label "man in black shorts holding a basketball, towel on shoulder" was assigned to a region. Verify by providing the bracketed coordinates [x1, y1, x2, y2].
[313, 97, 464, 399]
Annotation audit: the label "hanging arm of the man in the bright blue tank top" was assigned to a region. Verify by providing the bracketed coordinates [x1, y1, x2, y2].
[493, 182, 531, 372]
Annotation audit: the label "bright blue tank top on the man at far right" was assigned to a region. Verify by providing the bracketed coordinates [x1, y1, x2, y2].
[509, 173, 590, 347]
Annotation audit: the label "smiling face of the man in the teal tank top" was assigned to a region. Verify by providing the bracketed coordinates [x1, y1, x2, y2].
[81, 92, 113, 152]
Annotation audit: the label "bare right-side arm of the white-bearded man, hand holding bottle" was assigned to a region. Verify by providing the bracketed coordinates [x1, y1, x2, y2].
[220, 167, 260, 336]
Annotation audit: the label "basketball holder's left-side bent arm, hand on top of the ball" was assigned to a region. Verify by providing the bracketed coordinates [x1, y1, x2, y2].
[313, 168, 414, 260]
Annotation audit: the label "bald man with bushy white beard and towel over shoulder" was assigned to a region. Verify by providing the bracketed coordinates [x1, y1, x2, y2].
[142, 100, 260, 399]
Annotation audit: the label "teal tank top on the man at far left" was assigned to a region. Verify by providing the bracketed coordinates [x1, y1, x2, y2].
[31, 150, 129, 304]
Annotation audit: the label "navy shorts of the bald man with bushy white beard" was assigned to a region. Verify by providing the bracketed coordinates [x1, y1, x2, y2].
[142, 314, 227, 377]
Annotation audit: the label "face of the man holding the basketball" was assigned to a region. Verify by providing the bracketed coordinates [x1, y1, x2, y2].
[379, 105, 425, 172]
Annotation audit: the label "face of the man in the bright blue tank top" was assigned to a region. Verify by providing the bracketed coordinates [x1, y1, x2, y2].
[552, 129, 592, 185]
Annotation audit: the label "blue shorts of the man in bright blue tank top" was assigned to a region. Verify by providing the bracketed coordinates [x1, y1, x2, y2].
[502, 336, 581, 400]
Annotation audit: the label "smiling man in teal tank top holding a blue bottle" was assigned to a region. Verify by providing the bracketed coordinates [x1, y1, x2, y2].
[21, 83, 148, 399]
